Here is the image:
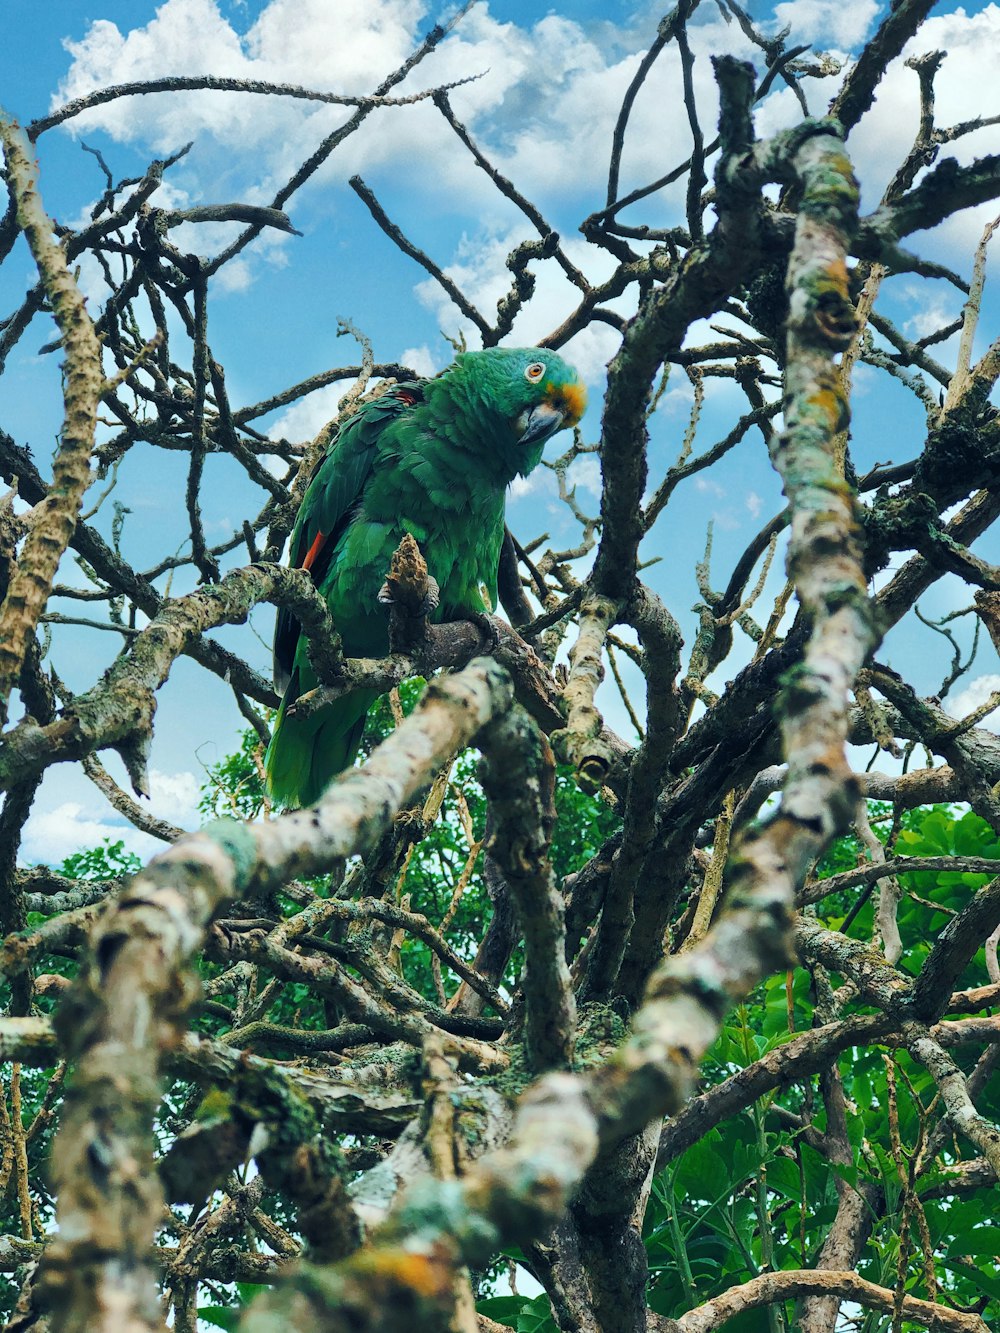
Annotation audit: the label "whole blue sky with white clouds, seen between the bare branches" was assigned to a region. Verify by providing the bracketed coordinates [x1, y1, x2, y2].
[0, 0, 1000, 858]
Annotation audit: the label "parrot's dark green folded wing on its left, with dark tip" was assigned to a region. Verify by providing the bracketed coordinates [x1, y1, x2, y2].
[275, 383, 423, 692]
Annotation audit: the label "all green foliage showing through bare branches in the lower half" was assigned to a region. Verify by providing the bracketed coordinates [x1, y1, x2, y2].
[35, 725, 1000, 1333]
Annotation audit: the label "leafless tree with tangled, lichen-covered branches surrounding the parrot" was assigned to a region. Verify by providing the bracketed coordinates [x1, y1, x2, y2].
[0, 0, 1000, 1333]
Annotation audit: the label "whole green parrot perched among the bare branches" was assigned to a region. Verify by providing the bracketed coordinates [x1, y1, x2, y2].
[264, 348, 587, 805]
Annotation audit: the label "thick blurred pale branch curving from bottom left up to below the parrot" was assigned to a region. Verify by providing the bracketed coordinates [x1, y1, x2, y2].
[37, 661, 511, 1330]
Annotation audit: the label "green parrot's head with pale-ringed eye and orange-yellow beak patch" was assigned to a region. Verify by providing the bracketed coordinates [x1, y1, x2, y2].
[445, 347, 587, 476]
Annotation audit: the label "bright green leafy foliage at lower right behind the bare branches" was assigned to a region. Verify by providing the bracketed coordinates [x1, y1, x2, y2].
[644, 802, 1000, 1333]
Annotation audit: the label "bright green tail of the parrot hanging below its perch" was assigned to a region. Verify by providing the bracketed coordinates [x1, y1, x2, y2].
[264, 672, 379, 808]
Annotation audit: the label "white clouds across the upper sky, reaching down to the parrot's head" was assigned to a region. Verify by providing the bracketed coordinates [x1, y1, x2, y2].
[49, 0, 1000, 389]
